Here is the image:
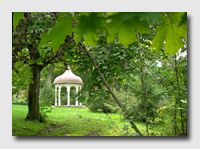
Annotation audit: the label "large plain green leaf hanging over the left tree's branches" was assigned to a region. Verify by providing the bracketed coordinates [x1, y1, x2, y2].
[39, 17, 72, 52]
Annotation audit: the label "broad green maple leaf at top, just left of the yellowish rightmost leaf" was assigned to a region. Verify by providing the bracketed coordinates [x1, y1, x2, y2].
[106, 13, 150, 47]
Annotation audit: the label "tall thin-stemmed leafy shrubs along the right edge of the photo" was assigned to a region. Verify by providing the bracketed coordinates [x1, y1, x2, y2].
[155, 48, 187, 135]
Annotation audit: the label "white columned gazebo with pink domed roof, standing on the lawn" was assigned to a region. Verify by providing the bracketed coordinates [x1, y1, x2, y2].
[53, 65, 83, 106]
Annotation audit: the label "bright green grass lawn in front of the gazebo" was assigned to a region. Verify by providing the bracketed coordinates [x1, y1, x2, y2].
[12, 105, 165, 136]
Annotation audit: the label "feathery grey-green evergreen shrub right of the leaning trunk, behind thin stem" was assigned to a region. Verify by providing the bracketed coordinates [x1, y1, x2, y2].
[128, 74, 165, 121]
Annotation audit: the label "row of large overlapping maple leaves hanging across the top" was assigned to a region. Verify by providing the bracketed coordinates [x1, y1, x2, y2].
[40, 12, 187, 54]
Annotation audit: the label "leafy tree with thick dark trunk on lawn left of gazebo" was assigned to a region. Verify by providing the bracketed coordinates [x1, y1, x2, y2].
[12, 13, 73, 121]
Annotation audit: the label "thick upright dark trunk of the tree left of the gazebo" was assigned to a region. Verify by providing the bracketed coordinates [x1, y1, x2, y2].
[26, 64, 41, 121]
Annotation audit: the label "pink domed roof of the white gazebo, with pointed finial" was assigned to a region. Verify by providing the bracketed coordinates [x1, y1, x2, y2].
[54, 66, 83, 83]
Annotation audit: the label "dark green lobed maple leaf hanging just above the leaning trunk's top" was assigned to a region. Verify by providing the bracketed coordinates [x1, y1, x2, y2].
[75, 13, 106, 47]
